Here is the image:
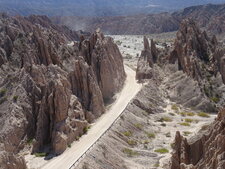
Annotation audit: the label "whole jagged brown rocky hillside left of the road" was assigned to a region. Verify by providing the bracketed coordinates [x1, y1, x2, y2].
[0, 14, 126, 169]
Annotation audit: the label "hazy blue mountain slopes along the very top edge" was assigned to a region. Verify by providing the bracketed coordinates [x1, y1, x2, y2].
[0, 0, 225, 16]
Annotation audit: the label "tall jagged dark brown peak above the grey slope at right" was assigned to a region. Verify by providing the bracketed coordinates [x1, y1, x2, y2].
[170, 20, 216, 79]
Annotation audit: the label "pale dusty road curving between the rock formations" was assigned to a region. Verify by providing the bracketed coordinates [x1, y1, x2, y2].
[42, 66, 141, 169]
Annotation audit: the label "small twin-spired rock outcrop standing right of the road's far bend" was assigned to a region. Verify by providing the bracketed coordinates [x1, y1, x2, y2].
[136, 36, 158, 81]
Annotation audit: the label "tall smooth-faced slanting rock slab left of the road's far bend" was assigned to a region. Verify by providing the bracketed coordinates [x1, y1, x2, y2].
[80, 29, 125, 101]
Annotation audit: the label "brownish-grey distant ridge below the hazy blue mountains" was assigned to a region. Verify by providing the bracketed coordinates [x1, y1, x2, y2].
[52, 4, 225, 35]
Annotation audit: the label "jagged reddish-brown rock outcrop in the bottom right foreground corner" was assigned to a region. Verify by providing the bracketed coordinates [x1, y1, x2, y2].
[170, 109, 225, 169]
